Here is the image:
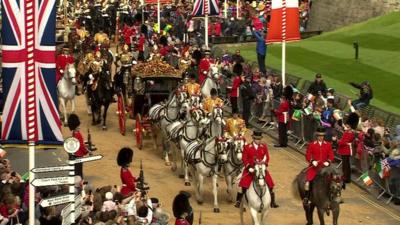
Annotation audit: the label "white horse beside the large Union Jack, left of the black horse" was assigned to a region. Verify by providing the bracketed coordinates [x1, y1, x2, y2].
[57, 64, 77, 124]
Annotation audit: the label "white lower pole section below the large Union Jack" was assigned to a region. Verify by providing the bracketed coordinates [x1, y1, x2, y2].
[28, 142, 36, 225]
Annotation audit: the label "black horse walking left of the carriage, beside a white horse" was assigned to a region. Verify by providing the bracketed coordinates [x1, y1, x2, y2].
[87, 67, 113, 130]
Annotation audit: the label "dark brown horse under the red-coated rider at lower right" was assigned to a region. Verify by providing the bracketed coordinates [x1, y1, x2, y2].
[293, 166, 342, 225]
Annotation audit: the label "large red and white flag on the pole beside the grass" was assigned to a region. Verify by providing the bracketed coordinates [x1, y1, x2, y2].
[266, 0, 300, 43]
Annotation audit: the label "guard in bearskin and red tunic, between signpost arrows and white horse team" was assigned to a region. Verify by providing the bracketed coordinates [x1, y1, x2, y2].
[117, 148, 136, 197]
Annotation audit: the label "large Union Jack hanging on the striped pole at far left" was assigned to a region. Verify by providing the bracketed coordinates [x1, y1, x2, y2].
[1, 0, 63, 144]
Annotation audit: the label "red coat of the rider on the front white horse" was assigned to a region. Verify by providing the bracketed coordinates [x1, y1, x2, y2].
[239, 143, 274, 188]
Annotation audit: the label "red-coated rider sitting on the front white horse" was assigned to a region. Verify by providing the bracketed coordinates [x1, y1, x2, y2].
[235, 131, 279, 208]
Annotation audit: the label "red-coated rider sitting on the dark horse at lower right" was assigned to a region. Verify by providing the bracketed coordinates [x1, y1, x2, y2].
[303, 127, 334, 205]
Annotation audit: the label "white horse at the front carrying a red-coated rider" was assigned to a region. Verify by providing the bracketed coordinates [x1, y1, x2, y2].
[240, 156, 271, 225]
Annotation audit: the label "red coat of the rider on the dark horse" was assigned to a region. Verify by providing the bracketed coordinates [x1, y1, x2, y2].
[306, 141, 333, 181]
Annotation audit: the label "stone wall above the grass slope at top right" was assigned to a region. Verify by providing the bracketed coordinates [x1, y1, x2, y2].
[307, 0, 400, 31]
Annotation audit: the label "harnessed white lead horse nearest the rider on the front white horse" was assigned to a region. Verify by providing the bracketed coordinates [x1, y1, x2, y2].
[224, 135, 245, 202]
